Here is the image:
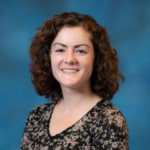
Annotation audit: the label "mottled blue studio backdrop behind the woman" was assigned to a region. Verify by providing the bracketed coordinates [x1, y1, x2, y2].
[0, 0, 150, 150]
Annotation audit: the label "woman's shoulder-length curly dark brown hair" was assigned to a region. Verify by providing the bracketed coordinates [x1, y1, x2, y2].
[30, 12, 124, 101]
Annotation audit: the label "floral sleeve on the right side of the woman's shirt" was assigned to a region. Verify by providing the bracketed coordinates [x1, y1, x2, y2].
[93, 111, 129, 150]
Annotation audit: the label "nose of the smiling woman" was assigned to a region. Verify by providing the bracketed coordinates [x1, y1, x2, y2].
[64, 50, 77, 64]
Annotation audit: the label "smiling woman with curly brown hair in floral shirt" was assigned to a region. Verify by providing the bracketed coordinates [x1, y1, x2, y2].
[21, 13, 128, 150]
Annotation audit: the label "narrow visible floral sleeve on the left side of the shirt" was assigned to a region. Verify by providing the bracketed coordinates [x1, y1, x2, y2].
[20, 109, 37, 150]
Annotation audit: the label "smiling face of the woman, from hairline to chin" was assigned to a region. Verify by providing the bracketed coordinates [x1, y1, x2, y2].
[50, 27, 94, 88]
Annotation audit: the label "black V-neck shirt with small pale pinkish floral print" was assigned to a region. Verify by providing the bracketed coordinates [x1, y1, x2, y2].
[21, 100, 128, 150]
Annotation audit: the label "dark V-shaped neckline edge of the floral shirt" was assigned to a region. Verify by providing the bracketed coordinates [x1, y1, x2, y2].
[47, 99, 104, 139]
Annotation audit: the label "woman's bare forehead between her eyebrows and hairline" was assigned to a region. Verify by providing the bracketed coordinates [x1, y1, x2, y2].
[52, 27, 91, 44]
